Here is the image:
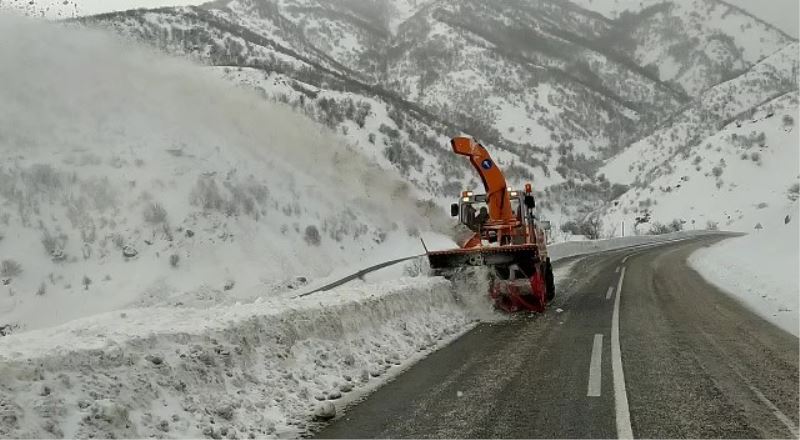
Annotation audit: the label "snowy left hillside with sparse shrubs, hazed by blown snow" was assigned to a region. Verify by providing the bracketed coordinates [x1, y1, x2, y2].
[0, 17, 450, 328]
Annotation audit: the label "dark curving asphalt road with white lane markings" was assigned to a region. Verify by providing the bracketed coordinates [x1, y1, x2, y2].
[317, 237, 799, 438]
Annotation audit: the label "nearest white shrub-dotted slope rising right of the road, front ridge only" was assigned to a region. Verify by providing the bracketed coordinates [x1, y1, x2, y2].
[606, 90, 800, 233]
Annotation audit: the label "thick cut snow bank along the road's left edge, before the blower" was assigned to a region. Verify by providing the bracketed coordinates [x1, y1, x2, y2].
[0, 278, 488, 438]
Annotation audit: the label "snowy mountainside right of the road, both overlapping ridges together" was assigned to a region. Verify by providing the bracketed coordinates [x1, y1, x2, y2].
[600, 43, 800, 231]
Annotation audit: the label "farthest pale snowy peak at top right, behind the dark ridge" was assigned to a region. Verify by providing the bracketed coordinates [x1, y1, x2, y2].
[575, 0, 795, 96]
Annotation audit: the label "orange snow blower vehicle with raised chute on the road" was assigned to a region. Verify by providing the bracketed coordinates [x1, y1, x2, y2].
[427, 136, 555, 313]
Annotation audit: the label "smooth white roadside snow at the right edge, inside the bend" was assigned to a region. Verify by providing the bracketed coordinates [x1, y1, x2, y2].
[689, 210, 800, 336]
